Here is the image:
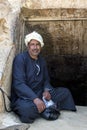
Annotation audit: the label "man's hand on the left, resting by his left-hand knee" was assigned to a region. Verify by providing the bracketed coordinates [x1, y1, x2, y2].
[34, 98, 46, 113]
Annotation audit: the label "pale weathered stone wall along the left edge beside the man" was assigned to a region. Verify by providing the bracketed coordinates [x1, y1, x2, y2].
[0, 0, 21, 112]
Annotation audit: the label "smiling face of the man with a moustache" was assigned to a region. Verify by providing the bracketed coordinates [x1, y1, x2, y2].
[28, 39, 41, 59]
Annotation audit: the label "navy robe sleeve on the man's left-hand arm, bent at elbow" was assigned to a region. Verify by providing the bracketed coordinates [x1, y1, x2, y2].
[13, 55, 37, 100]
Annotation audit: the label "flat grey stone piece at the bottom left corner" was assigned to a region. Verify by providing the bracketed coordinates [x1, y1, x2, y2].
[0, 123, 30, 130]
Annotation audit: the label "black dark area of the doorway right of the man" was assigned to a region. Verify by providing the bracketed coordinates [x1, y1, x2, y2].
[46, 55, 87, 106]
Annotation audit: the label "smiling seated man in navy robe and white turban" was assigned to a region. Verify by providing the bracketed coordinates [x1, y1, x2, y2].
[11, 31, 76, 123]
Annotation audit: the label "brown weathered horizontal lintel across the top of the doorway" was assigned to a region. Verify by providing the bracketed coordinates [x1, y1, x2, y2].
[21, 7, 87, 21]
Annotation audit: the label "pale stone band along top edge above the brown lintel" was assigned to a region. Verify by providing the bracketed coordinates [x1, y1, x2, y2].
[23, 0, 87, 9]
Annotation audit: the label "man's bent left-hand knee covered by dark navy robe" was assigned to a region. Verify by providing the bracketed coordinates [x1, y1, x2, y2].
[14, 101, 39, 123]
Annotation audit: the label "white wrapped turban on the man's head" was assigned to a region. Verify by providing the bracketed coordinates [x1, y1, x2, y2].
[25, 31, 44, 47]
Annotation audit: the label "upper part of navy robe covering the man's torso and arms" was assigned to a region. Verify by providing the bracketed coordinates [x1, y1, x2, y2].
[11, 52, 51, 103]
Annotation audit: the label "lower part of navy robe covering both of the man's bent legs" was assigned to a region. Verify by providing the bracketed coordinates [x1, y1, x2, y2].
[13, 87, 76, 123]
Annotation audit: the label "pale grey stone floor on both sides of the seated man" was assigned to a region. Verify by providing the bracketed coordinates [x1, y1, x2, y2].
[0, 106, 87, 130]
